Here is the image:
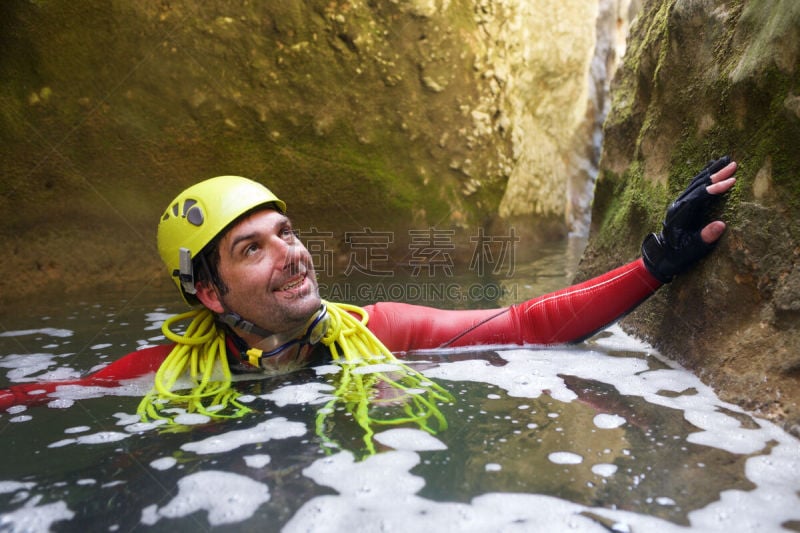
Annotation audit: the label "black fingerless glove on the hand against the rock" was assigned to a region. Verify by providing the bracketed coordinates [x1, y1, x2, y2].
[642, 156, 731, 283]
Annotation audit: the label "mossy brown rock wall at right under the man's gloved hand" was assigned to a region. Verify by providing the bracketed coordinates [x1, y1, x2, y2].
[581, 0, 800, 434]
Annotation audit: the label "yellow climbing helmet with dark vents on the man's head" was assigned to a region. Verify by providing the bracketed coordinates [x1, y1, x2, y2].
[158, 176, 286, 305]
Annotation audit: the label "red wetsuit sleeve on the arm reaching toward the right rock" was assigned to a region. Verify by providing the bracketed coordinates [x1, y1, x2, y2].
[366, 259, 661, 352]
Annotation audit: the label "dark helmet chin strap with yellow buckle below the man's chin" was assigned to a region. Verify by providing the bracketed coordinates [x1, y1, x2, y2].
[218, 303, 330, 367]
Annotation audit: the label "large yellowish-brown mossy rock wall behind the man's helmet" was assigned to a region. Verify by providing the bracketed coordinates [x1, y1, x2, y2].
[0, 0, 630, 298]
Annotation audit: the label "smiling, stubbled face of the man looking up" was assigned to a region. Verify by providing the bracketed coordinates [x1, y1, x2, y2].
[198, 210, 321, 333]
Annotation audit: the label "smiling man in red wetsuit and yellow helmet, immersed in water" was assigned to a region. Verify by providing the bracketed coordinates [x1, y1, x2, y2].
[0, 157, 737, 408]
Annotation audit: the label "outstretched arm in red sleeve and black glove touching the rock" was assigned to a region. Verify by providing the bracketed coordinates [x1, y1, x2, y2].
[367, 158, 736, 352]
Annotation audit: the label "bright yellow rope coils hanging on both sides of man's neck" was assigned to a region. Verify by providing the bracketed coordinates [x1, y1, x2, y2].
[137, 302, 452, 454]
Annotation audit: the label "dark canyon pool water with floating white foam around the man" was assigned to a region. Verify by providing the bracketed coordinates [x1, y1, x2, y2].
[0, 239, 800, 532]
